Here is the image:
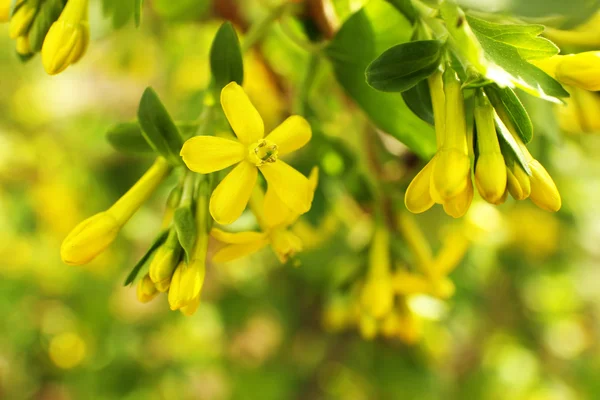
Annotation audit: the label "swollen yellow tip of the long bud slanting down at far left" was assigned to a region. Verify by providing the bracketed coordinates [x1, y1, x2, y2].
[60, 211, 122, 265]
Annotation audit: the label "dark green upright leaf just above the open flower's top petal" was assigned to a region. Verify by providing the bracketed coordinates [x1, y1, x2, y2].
[210, 22, 244, 90]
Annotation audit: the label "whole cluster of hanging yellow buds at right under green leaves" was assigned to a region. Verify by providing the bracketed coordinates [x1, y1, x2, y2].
[405, 67, 561, 218]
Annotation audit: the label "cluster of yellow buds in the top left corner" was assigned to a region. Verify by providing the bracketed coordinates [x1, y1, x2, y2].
[0, 0, 89, 75]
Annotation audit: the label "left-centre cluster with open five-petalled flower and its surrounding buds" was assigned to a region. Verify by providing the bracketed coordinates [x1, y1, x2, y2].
[61, 82, 318, 315]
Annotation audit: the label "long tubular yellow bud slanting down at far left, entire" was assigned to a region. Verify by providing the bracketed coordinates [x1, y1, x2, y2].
[60, 157, 170, 265]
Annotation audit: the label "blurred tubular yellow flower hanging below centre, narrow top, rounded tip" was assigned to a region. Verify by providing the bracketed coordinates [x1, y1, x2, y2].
[360, 225, 394, 319]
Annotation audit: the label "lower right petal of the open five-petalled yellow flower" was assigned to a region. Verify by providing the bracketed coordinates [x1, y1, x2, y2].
[259, 160, 314, 214]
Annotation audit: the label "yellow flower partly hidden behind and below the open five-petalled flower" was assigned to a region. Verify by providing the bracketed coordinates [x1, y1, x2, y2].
[211, 167, 319, 263]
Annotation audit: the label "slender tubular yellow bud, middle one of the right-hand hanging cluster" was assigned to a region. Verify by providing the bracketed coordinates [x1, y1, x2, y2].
[475, 92, 506, 204]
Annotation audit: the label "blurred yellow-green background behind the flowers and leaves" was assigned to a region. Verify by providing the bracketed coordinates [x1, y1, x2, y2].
[0, 0, 600, 400]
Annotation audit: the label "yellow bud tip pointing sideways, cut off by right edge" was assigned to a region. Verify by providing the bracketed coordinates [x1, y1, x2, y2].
[556, 51, 600, 91]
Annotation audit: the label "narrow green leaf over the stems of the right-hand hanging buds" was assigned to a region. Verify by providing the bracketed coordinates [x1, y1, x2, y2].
[484, 85, 533, 144]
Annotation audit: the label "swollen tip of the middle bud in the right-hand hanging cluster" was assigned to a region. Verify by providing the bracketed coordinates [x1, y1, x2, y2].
[475, 152, 507, 204]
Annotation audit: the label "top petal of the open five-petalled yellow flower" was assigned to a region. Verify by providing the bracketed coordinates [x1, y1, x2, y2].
[221, 82, 265, 144]
